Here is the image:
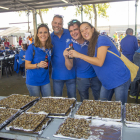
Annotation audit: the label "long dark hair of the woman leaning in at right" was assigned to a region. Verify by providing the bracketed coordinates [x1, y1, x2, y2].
[80, 22, 99, 57]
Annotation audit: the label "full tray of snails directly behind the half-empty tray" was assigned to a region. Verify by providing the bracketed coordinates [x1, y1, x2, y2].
[74, 100, 122, 121]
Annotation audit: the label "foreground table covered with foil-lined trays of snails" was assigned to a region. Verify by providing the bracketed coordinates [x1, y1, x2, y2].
[0, 95, 140, 140]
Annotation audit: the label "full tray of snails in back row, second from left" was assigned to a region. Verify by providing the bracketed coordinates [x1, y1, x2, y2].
[27, 97, 76, 118]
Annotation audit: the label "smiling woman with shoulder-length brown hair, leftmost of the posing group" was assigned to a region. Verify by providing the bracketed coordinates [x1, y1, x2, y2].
[25, 24, 52, 97]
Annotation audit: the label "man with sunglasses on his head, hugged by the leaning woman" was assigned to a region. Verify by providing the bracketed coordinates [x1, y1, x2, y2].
[63, 20, 101, 102]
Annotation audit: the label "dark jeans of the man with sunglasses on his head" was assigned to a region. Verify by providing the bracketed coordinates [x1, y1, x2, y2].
[76, 77, 101, 102]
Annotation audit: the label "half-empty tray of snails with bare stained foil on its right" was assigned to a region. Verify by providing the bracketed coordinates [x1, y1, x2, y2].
[53, 118, 122, 140]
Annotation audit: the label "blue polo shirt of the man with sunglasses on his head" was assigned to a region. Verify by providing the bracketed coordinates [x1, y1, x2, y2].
[66, 39, 96, 78]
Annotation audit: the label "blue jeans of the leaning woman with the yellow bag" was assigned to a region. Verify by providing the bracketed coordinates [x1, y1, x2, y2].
[100, 78, 131, 105]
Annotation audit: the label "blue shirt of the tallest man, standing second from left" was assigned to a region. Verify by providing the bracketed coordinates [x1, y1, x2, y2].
[51, 29, 75, 80]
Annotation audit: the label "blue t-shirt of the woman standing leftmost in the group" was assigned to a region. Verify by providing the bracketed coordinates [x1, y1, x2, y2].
[25, 44, 51, 86]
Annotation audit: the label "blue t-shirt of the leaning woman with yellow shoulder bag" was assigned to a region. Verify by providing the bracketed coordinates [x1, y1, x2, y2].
[92, 36, 130, 90]
